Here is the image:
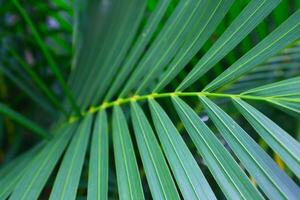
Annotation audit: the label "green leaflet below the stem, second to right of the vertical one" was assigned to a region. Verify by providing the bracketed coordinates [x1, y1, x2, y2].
[131, 102, 180, 200]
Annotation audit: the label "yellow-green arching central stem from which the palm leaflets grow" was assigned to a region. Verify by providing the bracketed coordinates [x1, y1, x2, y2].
[68, 92, 300, 123]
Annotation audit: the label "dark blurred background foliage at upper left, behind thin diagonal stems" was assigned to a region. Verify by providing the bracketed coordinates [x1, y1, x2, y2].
[0, 0, 73, 163]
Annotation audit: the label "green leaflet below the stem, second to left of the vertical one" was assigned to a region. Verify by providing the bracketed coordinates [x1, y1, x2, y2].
[9, 124, 77, 200]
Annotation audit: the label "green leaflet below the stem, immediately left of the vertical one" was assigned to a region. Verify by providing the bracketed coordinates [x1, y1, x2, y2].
[50, 115, 93, 200]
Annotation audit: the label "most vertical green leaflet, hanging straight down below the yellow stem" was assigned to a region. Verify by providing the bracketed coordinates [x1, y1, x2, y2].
[87, 110, 109, 200]
